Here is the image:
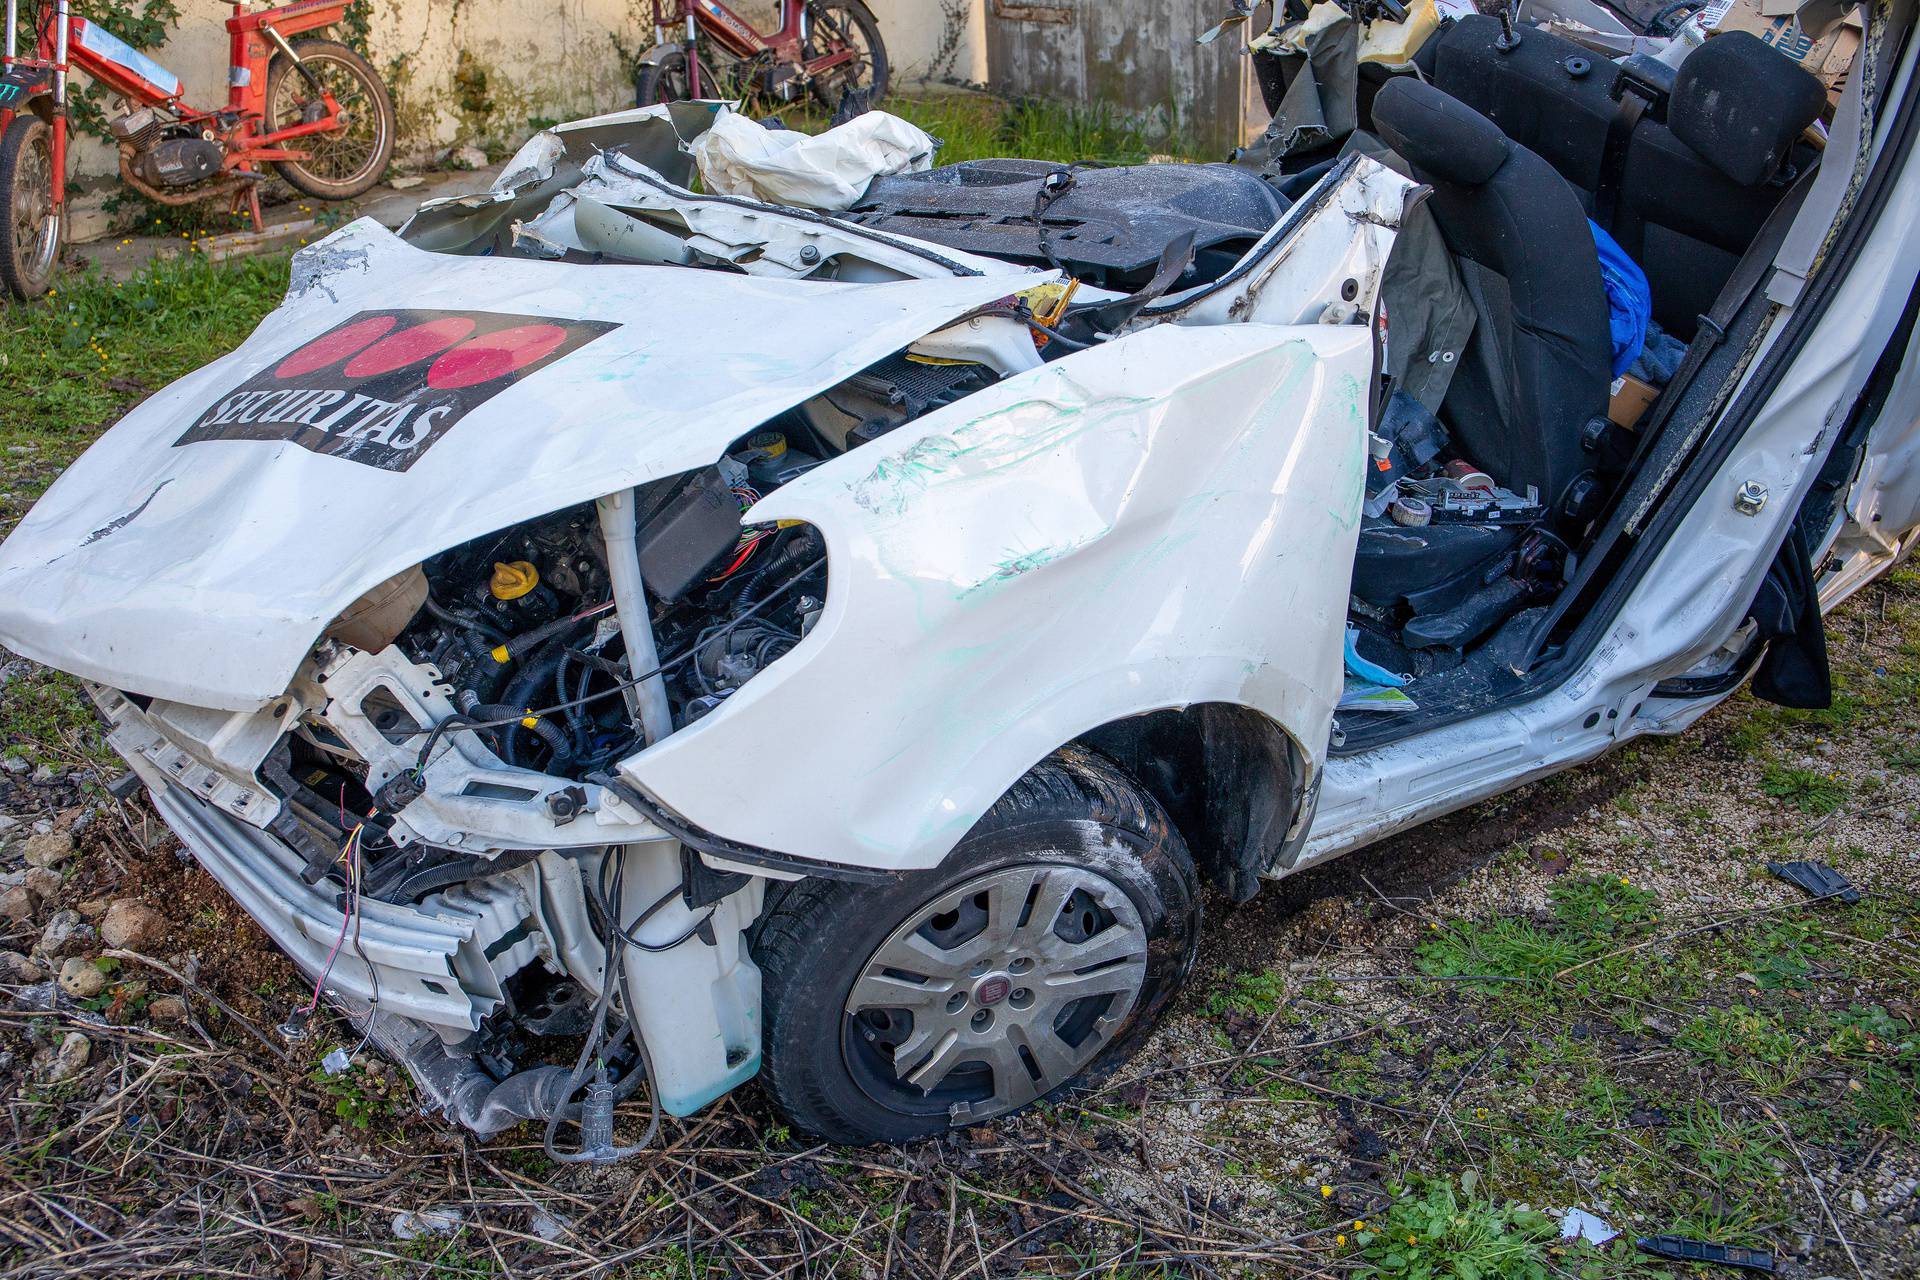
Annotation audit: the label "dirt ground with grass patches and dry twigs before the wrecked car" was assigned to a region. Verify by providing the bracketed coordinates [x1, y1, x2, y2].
[0, 570, 1920, 1278]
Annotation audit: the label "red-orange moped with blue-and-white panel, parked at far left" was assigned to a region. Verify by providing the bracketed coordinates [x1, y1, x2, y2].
[0, 0, 396, 299]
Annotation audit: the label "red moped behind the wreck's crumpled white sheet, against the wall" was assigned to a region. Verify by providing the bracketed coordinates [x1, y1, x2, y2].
[634, 0, 889, 111]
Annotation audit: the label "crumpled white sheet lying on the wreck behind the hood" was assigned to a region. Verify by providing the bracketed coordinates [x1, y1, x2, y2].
[691, 111, 939, 211]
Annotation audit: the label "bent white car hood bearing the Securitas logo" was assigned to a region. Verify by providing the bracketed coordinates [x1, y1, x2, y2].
[0, 221, 1008, 710]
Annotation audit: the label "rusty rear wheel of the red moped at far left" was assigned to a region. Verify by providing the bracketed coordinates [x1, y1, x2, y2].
[265, 40, 394, 200]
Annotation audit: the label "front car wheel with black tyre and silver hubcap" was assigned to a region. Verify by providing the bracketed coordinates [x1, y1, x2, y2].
[755, 748, 1200, 1144]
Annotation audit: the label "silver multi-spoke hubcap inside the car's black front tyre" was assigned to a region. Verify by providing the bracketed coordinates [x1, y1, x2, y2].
[843, 864, 1146, 1123]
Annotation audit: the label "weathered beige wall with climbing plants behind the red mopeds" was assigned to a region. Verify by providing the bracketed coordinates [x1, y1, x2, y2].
[75, 0, 987, 177]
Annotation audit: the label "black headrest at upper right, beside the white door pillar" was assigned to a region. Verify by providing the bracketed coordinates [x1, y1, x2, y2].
[1667, 31, 1826, 186]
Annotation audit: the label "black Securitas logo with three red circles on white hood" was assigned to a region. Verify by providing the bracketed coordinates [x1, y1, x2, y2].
[173, 311, 618, 472]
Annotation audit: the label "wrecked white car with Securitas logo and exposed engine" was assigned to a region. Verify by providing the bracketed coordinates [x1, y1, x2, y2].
[0, 0, 1920, 1159]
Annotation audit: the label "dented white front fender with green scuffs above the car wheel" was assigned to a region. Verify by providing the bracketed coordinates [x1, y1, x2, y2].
[620, 324, 1373, 867]
